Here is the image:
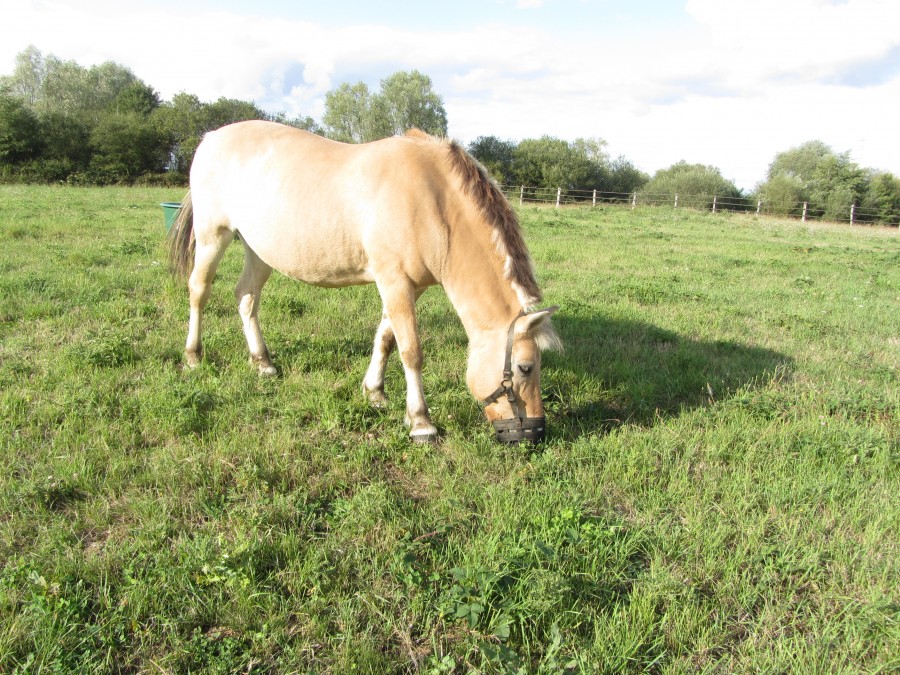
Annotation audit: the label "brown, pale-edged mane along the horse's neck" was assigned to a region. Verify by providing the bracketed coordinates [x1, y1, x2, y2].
[406, 129, 542, 309]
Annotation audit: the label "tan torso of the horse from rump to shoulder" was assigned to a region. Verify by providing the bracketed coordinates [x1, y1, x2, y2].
[191, 121, 447, 286]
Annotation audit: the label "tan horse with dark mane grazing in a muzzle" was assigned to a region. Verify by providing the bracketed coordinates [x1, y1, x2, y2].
[169, 121, 561, 443]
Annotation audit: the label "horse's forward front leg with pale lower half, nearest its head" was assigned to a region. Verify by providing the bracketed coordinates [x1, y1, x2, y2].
[367, 283, 437, 442]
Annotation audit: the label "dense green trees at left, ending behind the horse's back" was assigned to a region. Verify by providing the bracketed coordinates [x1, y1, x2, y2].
[0, 46, 324, 183]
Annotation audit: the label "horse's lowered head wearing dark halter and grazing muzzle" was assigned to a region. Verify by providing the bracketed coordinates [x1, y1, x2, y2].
[466, 307, 561, 443]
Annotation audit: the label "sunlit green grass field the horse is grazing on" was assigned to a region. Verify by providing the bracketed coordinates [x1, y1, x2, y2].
[0, 187, 900, 673]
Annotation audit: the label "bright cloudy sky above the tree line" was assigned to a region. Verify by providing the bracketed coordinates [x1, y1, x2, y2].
[0, 0, 900, 190]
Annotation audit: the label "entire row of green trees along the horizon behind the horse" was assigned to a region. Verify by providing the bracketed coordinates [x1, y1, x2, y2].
[0, 46, 900, 224]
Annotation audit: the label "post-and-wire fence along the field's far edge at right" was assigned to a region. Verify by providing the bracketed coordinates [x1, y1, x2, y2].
[500, 185, 900, 227]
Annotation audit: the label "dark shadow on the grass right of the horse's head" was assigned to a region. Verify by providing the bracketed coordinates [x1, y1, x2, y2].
[543, 313, 792, 440]
